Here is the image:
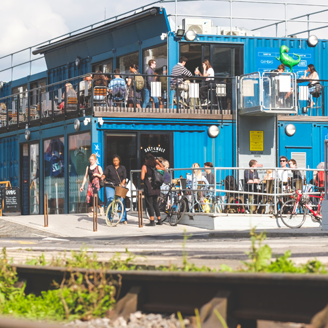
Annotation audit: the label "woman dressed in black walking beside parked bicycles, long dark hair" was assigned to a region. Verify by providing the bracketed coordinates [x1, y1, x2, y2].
[141, 153, 165, 227]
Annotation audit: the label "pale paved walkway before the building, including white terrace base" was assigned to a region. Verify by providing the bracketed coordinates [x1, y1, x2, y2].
[0, 214, 322, 238]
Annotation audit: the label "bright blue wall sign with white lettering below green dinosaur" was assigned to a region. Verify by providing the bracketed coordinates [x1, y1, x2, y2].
[256, 47, 315, 78]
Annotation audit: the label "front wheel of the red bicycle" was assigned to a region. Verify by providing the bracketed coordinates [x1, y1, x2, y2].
[280, 199, 306, 229]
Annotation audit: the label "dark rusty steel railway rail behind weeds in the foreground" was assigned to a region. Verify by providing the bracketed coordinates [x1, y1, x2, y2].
[4, 265, 328, 328]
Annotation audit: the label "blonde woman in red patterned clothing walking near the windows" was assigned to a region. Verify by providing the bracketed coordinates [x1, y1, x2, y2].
[80, 154, 104, 217]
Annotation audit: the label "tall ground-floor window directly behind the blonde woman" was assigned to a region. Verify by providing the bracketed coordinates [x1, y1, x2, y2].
[68, 132, 91, 213]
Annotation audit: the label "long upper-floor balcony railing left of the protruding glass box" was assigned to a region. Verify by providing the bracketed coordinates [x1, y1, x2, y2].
[0, 73, 233, 129]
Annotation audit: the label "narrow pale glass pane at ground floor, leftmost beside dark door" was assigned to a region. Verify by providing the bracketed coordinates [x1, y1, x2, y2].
[30, 144, 40, 214]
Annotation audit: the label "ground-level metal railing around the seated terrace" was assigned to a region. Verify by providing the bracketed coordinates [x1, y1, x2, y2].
[128, 167, 324, 216]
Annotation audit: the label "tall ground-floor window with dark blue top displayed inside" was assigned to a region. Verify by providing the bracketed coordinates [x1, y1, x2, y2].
[44, 137, 66, 214]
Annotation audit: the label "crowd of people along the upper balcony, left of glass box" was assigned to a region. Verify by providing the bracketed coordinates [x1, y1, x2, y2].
[58, 56, 220, 110]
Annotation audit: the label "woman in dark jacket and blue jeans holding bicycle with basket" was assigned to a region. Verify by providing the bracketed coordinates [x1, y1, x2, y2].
[101, 154, 128, 224]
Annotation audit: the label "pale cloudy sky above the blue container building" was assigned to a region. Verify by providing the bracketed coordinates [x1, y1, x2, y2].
[0, 0, 328, 80]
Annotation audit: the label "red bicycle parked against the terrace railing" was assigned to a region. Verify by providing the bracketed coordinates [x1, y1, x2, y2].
[280, 190, 324, 228]
